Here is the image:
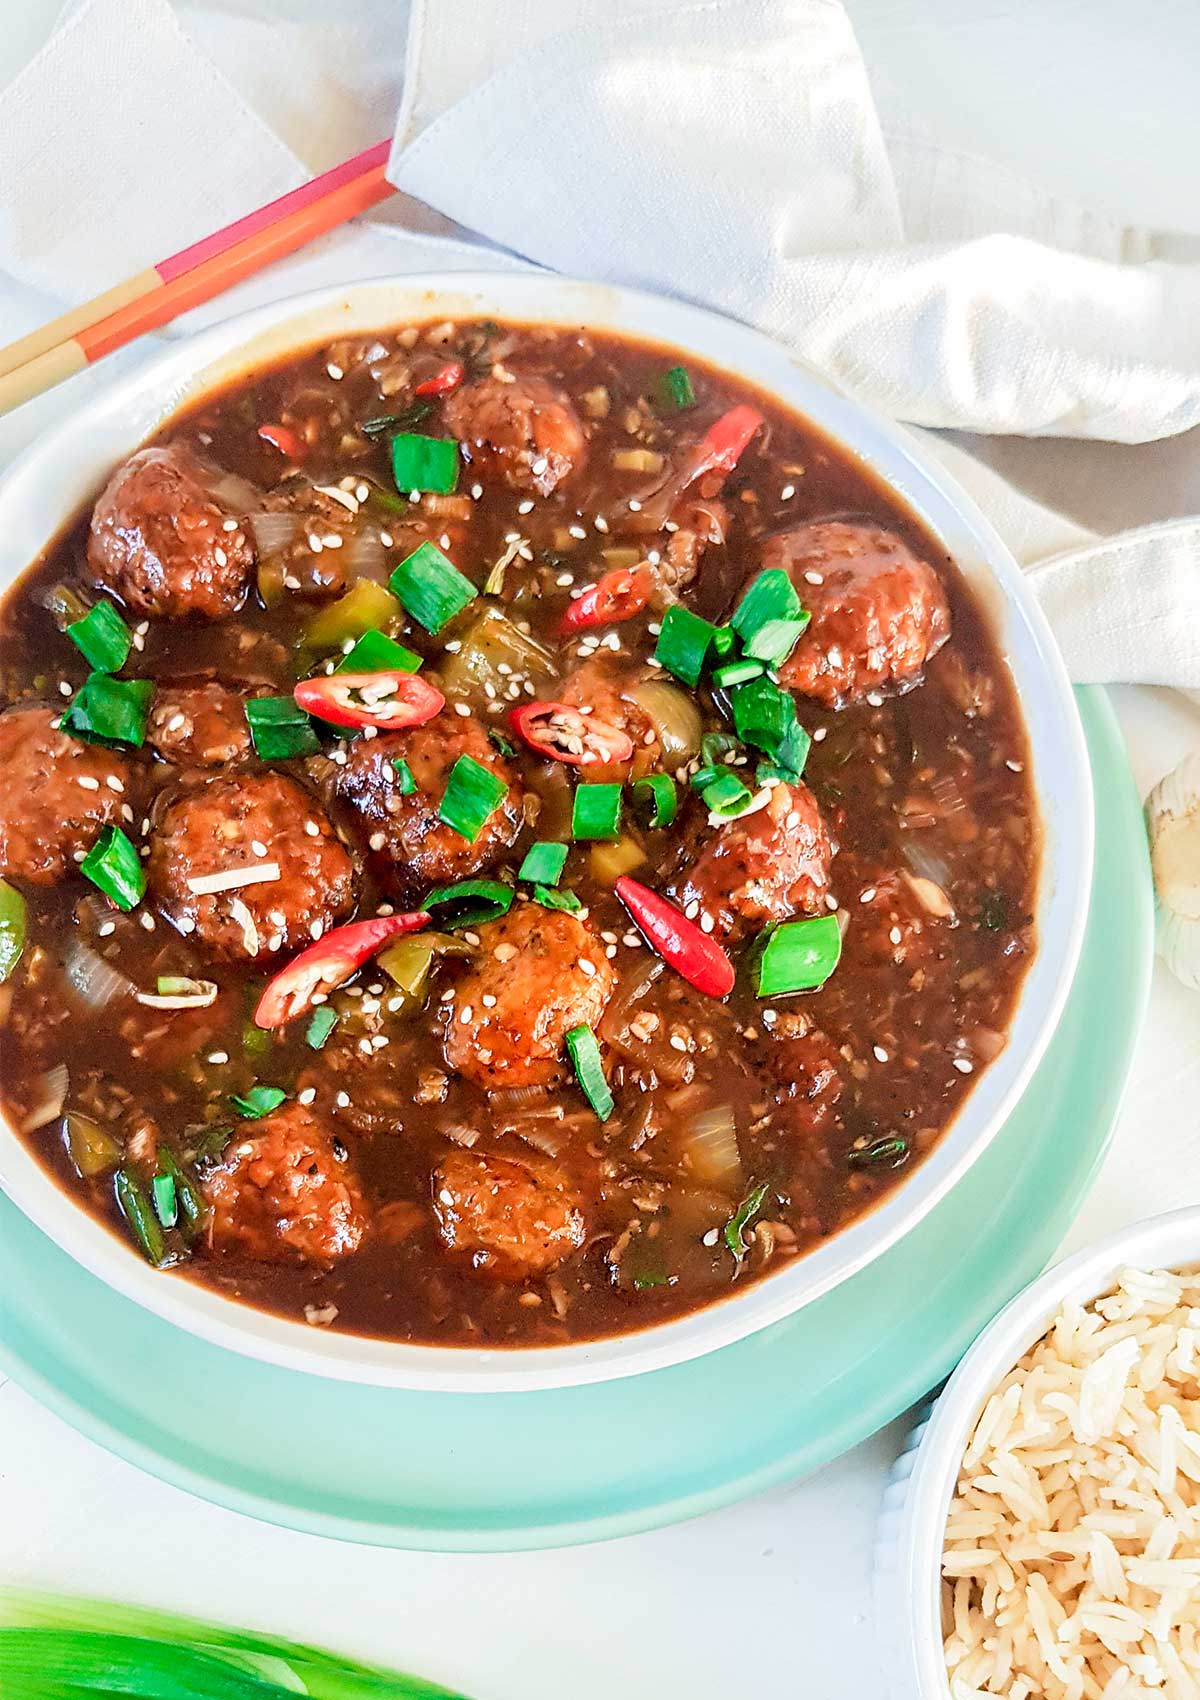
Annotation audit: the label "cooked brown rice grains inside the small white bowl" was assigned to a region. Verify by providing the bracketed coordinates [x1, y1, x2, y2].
[942, 1268, 1200, 1700]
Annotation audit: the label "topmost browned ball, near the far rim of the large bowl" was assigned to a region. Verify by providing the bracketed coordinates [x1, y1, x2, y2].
[444, 377, 586, 496]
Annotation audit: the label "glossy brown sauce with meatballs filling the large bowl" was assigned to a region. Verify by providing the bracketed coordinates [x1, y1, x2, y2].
[0, 325, 1039, 1345]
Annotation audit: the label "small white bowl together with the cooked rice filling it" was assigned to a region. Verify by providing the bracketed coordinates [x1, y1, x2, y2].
[875, 1207, 1200, 1700]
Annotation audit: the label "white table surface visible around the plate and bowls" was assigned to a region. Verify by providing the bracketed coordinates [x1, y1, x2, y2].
[0, 0, 1200, 1700]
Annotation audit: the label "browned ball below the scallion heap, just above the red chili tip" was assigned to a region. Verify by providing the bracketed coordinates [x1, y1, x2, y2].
[671, 784, 833, 938]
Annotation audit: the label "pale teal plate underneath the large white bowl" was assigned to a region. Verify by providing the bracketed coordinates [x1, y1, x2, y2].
[0, 690, 1152, 1550]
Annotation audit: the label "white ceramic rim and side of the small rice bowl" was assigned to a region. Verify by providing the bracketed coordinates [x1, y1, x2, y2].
[875, 1205, 1200, 1700]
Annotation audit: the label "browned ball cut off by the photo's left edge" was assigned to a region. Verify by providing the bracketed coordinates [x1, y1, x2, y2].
[0, 707, 131, 886]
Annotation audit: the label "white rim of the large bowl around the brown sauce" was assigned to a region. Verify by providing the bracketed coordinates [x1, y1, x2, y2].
[0, 274, 1093, 1392]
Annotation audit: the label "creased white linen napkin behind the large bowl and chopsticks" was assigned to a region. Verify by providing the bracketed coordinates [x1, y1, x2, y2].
[0, 0, 1200, 687]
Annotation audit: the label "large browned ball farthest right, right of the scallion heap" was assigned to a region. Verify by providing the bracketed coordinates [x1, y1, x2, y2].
[761, 520, 950, 707]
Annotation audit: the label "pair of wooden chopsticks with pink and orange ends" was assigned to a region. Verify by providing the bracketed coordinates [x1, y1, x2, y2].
[0, 141, 393, 413]
